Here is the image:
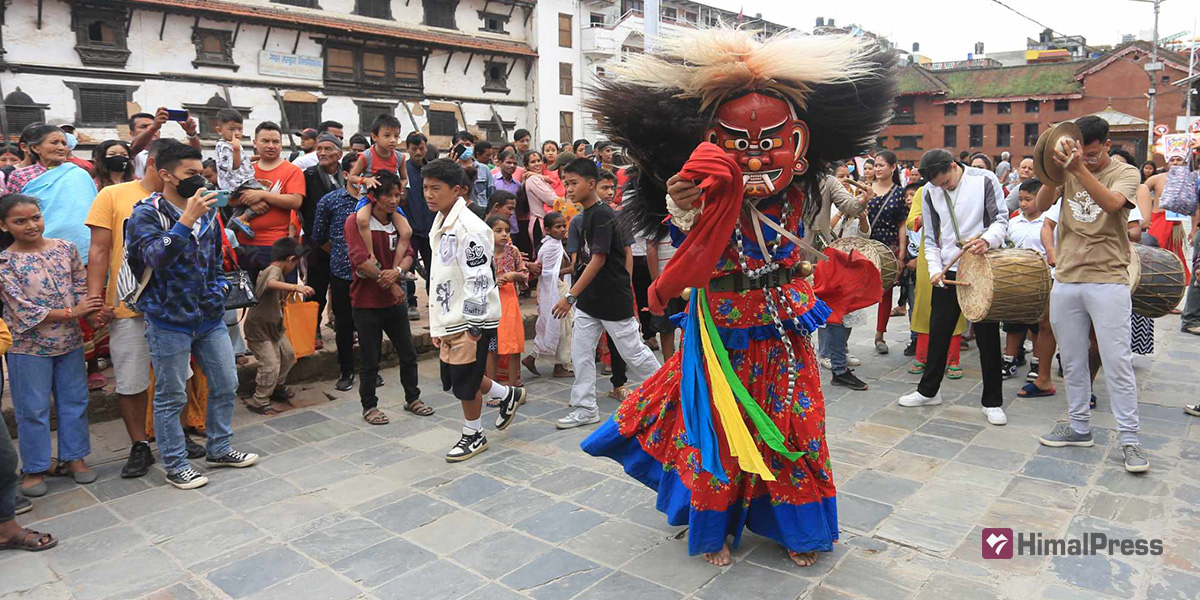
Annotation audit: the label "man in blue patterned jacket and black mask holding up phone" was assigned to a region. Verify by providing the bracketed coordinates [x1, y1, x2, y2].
[125, 143, 258, 490]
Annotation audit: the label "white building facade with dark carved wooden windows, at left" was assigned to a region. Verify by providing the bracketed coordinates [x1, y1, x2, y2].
[0, 0, 538, 154]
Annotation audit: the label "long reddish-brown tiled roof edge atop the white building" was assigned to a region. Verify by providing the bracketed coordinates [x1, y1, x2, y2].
[108, 0, 538, 56]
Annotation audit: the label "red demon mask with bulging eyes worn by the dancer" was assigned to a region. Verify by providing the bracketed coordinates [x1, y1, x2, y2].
[704, 92, 809, 198]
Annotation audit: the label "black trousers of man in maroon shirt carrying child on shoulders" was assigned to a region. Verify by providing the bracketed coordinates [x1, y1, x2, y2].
[350, 305, 420, 410]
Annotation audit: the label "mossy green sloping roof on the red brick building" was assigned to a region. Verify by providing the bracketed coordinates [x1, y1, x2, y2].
[937, 62, 1084, 101]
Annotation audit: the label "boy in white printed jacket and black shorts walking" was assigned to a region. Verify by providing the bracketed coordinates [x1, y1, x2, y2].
[421, 158, 526, 462]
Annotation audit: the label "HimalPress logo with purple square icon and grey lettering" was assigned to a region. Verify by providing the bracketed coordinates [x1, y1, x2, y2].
[983, 527, 1163, 559]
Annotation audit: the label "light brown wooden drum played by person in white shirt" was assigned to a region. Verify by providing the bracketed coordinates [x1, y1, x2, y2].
[955, 248, 1050, 323]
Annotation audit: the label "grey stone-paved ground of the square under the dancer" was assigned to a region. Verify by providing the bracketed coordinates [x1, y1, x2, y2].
[0, 318, 1200, 600]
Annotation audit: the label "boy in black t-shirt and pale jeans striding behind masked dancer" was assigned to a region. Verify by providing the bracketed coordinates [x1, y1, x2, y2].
[553, 158, 661, 430]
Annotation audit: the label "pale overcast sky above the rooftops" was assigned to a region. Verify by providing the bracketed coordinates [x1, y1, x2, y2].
[700, 0, 1200, 60]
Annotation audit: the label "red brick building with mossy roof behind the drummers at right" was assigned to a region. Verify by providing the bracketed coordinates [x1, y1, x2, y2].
[878, 41, 1188, 162]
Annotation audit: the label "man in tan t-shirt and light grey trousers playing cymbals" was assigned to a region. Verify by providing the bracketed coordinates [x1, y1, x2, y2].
[1038, 116, 1150, 473]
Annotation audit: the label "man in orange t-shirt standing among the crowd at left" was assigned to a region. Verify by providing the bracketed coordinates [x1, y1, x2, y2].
[229, 121, 305, 280]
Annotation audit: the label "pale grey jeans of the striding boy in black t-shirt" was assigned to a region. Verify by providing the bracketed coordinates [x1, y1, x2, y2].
[571, 307, 662, 414]
